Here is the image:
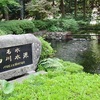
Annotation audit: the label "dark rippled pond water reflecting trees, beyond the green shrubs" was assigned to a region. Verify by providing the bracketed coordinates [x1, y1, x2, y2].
[49, 39, 100, 73]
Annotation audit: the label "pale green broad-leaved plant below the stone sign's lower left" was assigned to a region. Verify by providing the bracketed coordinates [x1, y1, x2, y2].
[0, 80, 14, 94]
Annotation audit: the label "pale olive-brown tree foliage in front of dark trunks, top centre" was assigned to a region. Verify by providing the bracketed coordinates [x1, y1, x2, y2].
[26, 0, 59, 19]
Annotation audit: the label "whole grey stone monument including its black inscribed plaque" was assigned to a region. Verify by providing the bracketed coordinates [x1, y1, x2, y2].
[0, 34, 41, 79]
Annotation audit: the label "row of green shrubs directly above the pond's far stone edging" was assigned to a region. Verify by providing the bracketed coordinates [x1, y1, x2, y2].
[33, 18, 79, 32]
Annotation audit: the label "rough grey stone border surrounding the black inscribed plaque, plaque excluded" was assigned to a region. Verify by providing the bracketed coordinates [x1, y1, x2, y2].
[0, 34, 41, 79]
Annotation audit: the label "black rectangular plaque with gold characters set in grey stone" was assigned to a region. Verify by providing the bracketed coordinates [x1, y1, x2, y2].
[0, 44, 32, 72]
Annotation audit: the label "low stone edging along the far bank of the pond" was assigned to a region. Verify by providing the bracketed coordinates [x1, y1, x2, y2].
[33, 31, 100, 40]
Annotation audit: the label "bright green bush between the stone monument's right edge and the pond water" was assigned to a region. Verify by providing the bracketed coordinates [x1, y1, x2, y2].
[39, 37, 55, 59]
